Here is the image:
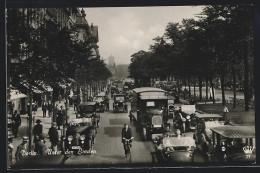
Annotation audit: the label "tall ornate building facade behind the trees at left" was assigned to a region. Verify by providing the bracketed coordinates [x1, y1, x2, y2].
[6, 8, 99, 111]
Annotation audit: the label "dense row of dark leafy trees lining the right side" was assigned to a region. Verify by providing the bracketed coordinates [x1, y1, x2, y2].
[129, 5, 254, 111]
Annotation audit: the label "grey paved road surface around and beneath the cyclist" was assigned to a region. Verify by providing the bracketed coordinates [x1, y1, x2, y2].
[64, 96, 204, 166]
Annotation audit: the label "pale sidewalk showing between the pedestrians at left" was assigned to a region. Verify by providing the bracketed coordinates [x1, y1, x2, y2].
[12, 100, 75, 164]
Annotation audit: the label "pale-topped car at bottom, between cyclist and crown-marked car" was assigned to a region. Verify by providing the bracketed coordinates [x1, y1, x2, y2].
[154, 135, 195, 163]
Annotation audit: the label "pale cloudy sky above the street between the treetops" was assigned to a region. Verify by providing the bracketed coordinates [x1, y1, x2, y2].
[84, 6, 202, 65]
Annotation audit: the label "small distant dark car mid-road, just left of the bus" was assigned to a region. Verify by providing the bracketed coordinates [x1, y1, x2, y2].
[113, 94, 128, 112]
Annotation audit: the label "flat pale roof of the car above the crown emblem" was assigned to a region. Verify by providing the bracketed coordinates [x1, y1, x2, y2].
[210, 125, 255, 138]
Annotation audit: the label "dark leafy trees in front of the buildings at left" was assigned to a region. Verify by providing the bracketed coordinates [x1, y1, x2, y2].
[7, 9, 111, 149]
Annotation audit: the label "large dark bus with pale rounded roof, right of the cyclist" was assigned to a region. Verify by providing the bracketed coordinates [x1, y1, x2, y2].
[131, 87, 169, 140]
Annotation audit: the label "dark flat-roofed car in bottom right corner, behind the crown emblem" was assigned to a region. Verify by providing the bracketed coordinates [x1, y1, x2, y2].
[204, 125, 256, 164]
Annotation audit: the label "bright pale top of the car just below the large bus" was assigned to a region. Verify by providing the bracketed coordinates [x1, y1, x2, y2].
[163, 136, 195, 147]
